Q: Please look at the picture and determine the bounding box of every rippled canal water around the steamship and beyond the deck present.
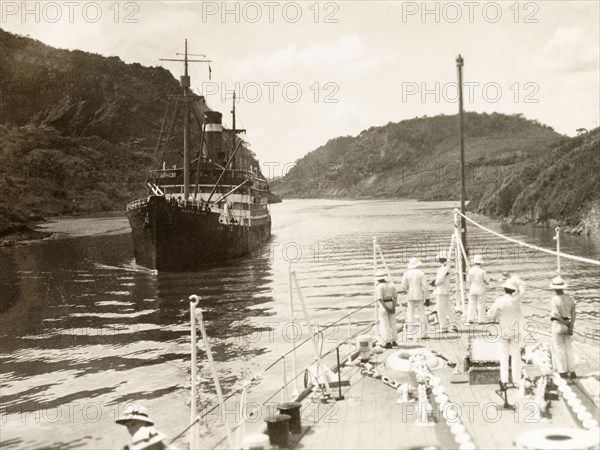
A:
[0,200,600,449]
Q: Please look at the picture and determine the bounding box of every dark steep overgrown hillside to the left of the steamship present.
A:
[0,29,258,238]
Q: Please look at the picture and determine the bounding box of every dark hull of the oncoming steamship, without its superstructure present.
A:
[127,196,271,271]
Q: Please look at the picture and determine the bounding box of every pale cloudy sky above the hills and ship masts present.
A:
[0,0,600,172]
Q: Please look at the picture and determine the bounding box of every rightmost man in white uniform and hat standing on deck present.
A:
[550,277,577,378]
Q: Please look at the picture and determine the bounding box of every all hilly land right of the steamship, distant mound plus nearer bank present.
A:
[274,113,600,232]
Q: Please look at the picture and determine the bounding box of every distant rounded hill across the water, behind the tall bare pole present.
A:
[274,113,565,200]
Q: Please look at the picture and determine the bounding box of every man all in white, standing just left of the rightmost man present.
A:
[488,279,523,384]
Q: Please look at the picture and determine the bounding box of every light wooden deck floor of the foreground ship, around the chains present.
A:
[294,327,599,449]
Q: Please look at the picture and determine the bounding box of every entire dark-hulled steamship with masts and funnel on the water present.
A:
[127,41,279,271]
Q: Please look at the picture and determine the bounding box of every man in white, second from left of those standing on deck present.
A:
[400,258,429,340]
